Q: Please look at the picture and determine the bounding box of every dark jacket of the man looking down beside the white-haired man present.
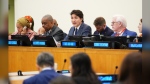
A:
[93,26,114,36]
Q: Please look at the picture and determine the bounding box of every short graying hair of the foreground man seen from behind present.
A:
[37,52,54,67]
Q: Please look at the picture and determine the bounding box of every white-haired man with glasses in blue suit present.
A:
[111,15,137,36]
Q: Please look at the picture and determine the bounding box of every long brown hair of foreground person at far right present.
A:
[119,52,142,84]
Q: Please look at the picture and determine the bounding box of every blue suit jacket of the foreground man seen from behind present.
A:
[23,69,59,84]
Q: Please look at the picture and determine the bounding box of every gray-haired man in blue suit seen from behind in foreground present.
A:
[23,52,59,84]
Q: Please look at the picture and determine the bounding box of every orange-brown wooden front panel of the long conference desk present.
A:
[8,46,138,74]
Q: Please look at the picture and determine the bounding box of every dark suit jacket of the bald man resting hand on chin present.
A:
[44,26,64,41]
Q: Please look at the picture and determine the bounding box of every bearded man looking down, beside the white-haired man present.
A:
[93,17,114,36]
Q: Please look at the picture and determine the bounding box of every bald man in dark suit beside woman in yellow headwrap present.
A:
[42,15,64,41]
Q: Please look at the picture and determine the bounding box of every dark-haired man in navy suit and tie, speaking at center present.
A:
[64,10,92,40]
